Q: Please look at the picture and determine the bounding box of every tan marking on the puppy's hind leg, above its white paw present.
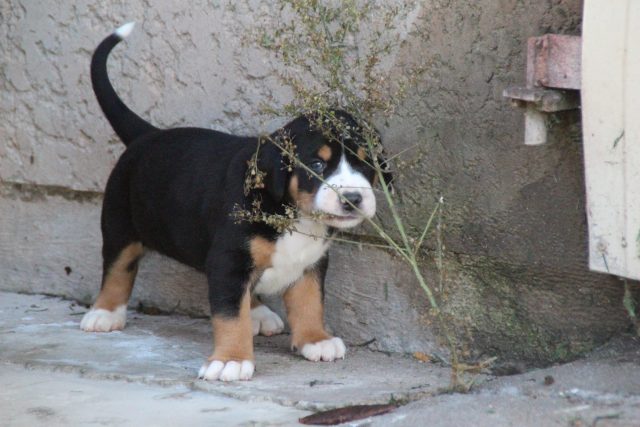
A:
[93,242,143,311]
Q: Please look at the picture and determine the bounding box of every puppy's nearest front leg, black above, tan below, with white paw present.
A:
[198,251,255,381]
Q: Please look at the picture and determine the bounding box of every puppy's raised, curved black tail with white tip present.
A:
[91,22,158,145]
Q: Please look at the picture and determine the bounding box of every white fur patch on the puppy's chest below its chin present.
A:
[255,219,330,294]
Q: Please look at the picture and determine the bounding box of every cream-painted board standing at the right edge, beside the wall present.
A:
[582,0,640,279]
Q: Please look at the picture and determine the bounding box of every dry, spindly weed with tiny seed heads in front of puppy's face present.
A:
[236,0,493,392]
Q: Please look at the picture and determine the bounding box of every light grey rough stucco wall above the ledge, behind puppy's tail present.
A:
[0,1,290,191]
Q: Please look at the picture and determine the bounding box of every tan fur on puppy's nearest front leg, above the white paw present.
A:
[209,290,253,362]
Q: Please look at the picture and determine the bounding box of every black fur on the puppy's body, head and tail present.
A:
[91,26,374,316]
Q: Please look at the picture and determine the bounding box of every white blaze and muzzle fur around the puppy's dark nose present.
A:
[314,154,376,228]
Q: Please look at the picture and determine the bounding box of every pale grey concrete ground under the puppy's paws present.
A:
[0,292,640,427]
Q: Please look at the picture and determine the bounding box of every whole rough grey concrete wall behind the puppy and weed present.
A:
[0,0,629,366]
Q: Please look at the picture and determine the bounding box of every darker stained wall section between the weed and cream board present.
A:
[385,1,628,364]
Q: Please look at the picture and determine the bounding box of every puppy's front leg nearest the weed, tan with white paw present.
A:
[284,270,346,362]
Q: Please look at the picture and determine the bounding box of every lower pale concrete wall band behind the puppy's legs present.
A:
[0,185,446,354]
